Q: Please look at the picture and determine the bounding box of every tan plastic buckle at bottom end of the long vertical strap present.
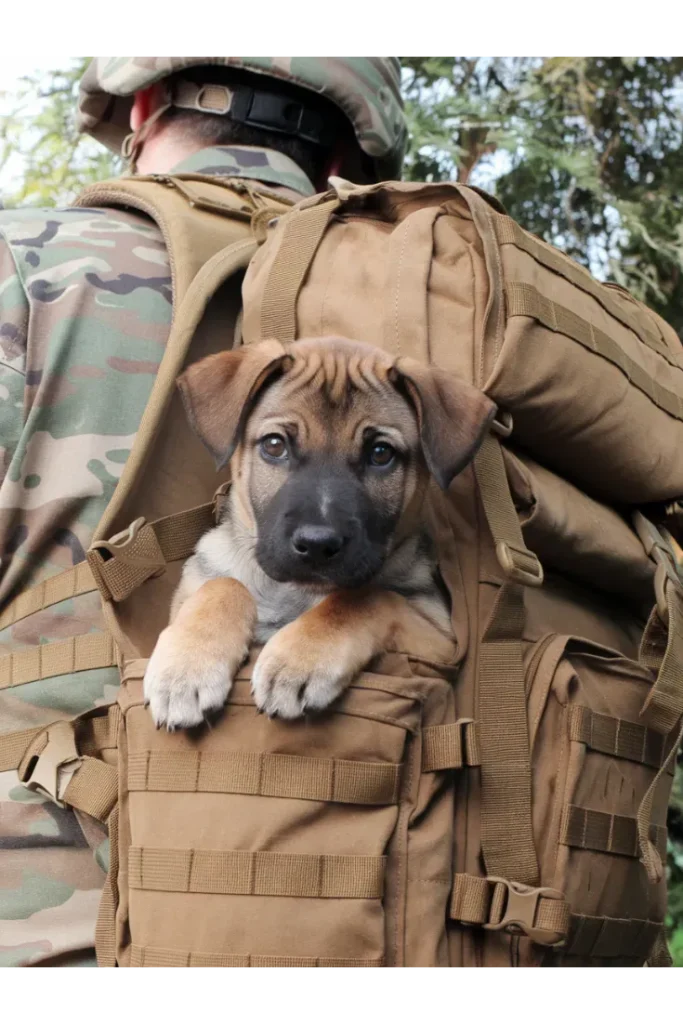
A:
[483,877,569,946]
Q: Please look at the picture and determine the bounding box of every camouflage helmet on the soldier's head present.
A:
[78,56,408,179]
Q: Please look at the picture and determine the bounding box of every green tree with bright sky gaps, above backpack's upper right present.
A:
[402,56,683,335]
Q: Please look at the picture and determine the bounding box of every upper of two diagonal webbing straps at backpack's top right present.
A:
[494,217,683,370]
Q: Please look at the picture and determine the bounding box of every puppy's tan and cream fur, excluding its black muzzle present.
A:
[145,339,493,728]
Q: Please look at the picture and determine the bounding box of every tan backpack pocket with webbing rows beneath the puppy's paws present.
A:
[108,659,454,967]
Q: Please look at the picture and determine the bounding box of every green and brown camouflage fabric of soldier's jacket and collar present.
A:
[0,146,313,968]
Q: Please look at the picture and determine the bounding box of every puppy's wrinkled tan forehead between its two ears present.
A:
[244,342,417,444]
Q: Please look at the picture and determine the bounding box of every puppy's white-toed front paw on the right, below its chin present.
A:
[252,622,361,719]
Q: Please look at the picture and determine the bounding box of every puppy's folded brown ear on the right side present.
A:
[393,358,496,490]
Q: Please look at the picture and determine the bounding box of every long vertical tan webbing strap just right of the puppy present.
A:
[474,434,543,885]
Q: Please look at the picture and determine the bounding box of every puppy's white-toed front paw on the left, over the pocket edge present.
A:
[144,626,248,732]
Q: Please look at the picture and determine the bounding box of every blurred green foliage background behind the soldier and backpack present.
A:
[0,56,683,967]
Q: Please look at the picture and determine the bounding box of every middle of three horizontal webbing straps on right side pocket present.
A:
[559,804,667,857]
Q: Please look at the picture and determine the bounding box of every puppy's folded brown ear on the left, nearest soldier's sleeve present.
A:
[178,341,290,469]
